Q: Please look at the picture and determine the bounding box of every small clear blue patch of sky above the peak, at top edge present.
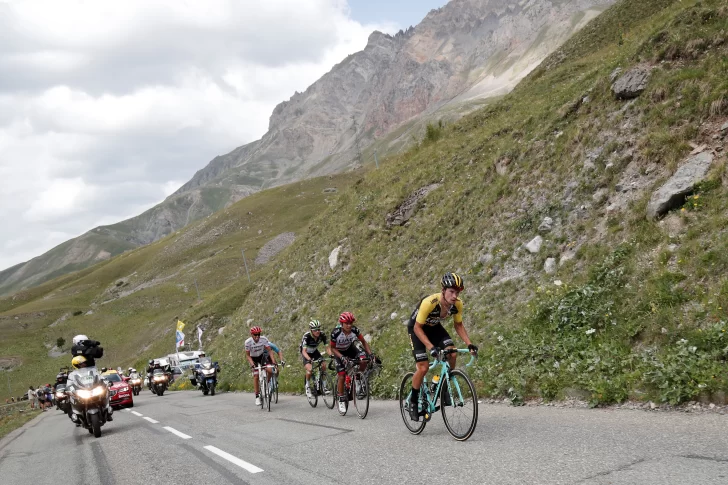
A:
[348,0,447,28]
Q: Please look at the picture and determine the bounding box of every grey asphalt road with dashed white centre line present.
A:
[0,390,728,485]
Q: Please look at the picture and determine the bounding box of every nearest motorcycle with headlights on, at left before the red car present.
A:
[70,371,109,438]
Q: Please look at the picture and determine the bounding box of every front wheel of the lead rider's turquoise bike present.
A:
[440,369,478,441]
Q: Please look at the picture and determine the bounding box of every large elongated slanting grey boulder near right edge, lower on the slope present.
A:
[647,152,713,219]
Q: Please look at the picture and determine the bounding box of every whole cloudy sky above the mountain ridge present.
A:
[0,0,446,269]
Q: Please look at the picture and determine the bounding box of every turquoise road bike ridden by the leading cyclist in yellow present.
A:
[399,349,478,441]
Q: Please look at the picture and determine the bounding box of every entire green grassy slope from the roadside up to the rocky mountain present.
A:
[0,0,728,404]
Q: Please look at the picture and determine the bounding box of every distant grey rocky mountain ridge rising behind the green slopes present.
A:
[0,0,614,294]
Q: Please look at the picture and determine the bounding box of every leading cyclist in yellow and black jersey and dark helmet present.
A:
[407,273,478,421]
